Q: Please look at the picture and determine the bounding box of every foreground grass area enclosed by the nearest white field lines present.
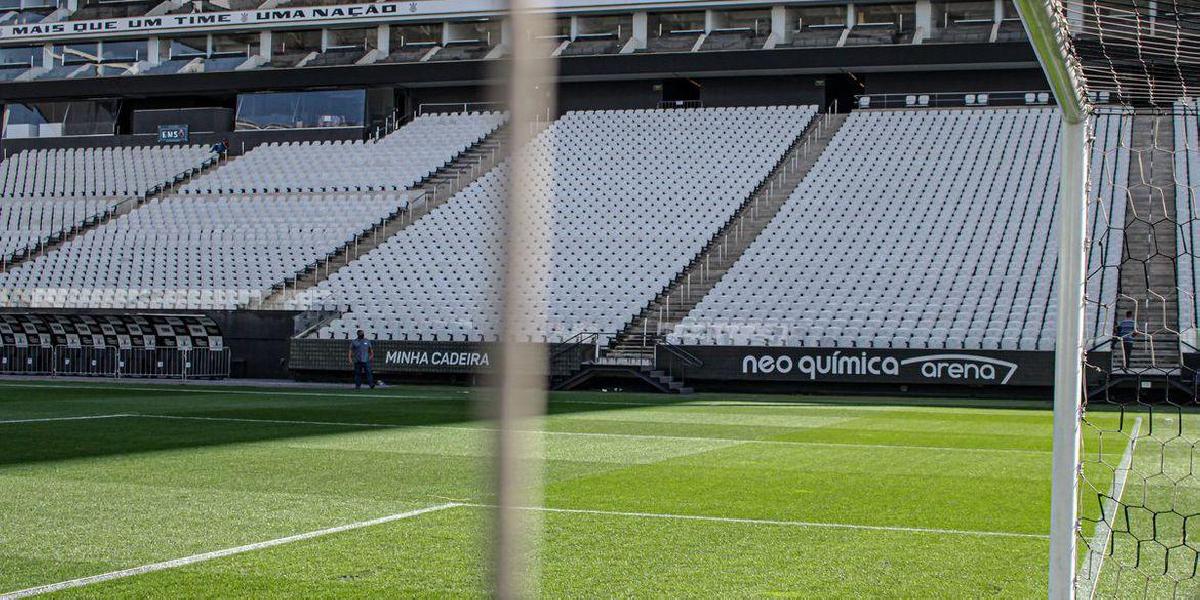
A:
[51,510,1046,599]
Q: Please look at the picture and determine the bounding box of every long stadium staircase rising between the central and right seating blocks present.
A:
[605,113,847,361]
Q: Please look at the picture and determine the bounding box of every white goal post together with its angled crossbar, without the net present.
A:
[1015,0,1091,600]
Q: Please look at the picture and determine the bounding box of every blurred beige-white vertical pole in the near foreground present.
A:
[492,0,554,599]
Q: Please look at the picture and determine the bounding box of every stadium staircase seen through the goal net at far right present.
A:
[1112,115,1181,376]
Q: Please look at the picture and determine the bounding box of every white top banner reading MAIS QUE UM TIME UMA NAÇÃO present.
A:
[0,0,714,42]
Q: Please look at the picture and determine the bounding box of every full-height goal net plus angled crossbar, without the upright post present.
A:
[1022,0,1200,590]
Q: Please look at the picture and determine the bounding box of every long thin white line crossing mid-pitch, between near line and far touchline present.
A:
[128,414,1050,455]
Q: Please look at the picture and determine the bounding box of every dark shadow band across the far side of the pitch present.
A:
[0,380,1099,464]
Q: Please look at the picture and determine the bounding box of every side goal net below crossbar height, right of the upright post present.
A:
[1078,102,1200,598]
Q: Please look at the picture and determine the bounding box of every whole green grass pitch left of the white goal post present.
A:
[0,382,1171,598]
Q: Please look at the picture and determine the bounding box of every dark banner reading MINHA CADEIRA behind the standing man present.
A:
[288,340,498,374]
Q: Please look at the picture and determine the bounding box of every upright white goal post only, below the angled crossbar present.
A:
[1049,113,1090,600]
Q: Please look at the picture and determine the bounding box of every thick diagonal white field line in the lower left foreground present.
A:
[0,502,463,600]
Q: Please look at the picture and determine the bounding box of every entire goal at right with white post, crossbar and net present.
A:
[1015,0,1200,599]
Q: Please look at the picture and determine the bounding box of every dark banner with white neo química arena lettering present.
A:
[658,346,1054,386]
